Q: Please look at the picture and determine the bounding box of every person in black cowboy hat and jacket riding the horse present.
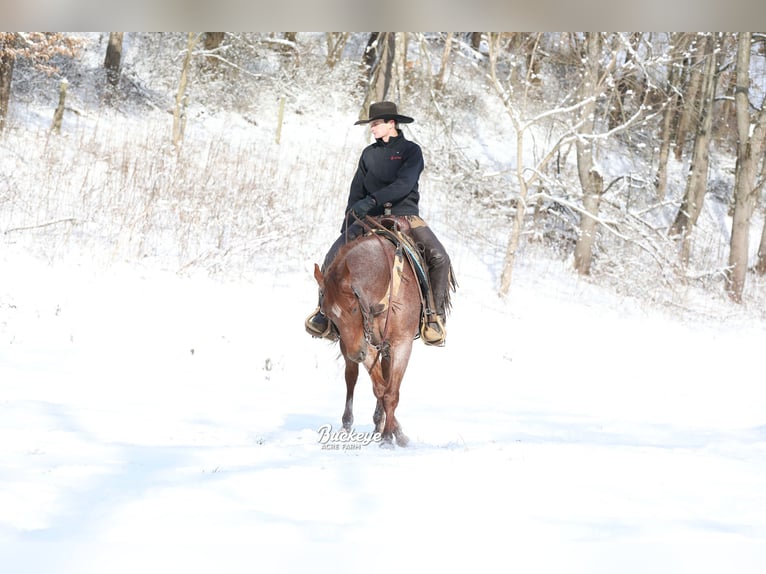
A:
[305,102,450,345]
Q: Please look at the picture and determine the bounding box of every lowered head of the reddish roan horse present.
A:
[314,264,368,363]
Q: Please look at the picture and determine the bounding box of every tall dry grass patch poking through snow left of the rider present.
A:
[0,112,348,280]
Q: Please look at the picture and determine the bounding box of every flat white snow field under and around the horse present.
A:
[0,240,766,574]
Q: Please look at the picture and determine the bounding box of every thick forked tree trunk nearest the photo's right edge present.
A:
[726,32,766,303]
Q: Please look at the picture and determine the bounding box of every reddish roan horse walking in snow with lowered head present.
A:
[314,220,423,448]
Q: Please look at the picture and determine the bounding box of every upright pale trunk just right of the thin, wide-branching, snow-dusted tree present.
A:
[574,32,604,275]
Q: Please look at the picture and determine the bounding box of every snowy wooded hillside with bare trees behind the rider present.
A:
[0,32,766,310]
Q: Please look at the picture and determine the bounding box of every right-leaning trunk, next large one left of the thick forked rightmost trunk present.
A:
[669,34,716,260]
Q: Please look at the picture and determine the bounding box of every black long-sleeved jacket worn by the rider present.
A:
[346,132,423,222]
